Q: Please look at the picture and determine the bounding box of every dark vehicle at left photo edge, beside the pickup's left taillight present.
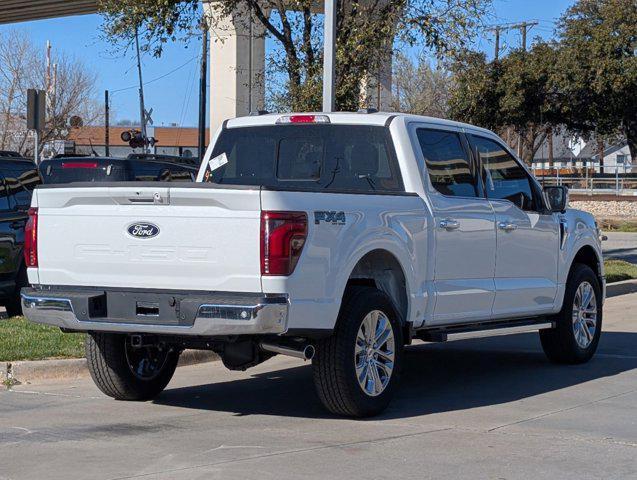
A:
[0,155,40,316]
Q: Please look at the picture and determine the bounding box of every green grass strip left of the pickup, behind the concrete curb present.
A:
[0,317,84,362]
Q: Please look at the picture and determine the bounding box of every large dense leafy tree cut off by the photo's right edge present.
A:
[552,0,637,161]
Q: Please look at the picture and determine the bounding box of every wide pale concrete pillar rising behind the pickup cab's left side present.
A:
[204,3,265,133]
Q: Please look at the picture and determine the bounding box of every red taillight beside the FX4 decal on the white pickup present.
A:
[261,212,307,276]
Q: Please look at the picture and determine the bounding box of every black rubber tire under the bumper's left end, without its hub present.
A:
[85,332,179,401]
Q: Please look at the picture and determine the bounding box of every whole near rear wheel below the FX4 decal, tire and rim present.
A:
[312,287,403,417]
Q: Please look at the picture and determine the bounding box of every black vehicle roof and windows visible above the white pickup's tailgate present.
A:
[40,156,198,184]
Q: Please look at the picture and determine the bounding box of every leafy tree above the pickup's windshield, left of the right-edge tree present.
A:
[450,42,558,164]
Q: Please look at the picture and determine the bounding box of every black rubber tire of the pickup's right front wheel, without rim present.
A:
[540,263,602,365]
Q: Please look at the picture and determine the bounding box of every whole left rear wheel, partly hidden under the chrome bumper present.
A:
[86,332,179,401]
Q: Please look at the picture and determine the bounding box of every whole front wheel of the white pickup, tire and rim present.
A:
[540,264,602,364]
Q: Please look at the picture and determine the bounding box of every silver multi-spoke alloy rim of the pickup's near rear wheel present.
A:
[354,310,396,397]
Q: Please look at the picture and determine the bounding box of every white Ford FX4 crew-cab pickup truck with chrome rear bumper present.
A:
[22,112,605,417]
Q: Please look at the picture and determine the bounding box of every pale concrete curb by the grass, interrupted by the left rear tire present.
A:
[0,350,219,385]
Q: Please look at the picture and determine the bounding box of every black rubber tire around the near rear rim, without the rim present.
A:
[312,287,403,417]
